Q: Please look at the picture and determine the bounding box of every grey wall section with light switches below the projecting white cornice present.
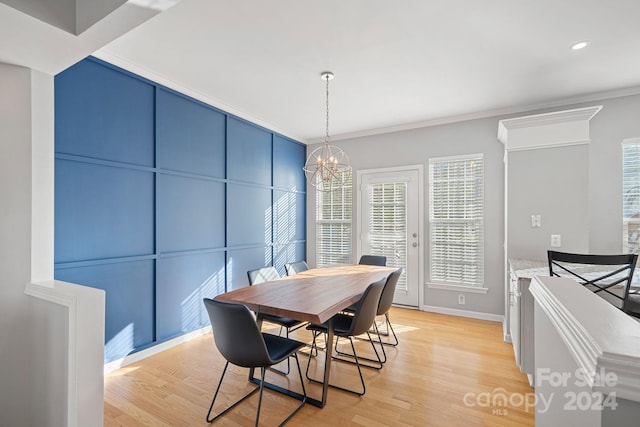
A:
[507,144,589,261]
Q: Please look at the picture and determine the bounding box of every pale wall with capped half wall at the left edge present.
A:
[0,63,104,427]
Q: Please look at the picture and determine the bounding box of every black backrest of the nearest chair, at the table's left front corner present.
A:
[203,298,271,368]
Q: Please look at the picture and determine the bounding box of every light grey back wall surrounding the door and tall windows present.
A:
[307,118,504,315]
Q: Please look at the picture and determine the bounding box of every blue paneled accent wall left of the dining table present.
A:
[55,57,306,362]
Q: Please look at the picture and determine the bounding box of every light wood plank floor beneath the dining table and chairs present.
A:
[104,307,534,427]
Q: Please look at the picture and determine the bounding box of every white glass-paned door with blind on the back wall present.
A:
[357,165,424,307]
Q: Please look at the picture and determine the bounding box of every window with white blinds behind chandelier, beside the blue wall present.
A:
[316,173,353,267]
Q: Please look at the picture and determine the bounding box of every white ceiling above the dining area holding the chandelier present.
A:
[0,0,640,142]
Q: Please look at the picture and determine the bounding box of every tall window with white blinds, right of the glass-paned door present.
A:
[429,154,484,287]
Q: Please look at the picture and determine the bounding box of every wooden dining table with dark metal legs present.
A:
[215,264,397,408]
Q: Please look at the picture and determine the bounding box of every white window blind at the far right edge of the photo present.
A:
[622,138,640,254]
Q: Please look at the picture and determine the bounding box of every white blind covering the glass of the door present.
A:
[369,181,407,290]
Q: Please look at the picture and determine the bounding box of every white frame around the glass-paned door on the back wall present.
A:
[355,164,424,310]
